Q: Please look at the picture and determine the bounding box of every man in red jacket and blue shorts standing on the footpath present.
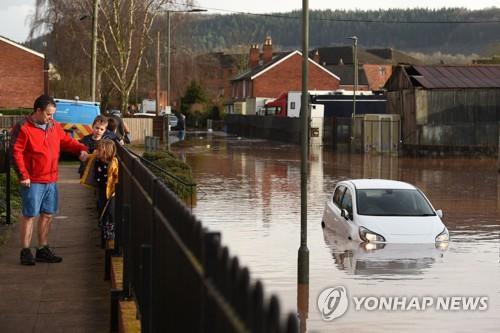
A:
[12,95,88,265]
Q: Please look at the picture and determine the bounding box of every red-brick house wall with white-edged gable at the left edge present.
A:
[0,36,46,108]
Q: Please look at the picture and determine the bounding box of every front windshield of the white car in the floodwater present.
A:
[356,189,436,216]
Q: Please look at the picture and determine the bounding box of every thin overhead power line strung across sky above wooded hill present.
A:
[171,1,500,24]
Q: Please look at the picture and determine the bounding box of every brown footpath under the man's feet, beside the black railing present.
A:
[0,165,110,333]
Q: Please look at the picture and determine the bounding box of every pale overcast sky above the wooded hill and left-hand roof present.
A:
[0,0,500,42]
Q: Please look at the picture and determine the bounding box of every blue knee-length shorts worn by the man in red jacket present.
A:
[20,183,58,217]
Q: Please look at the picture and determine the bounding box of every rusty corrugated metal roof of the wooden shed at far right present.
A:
[411,65,500,89]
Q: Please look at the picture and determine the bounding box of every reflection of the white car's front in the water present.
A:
[323,228,448,280]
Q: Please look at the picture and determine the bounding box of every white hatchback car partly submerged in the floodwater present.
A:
[322,179,449,244]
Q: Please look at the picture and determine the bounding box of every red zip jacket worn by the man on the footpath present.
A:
[11,116,87,183]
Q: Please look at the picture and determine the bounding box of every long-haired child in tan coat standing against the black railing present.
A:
[80,139,118,245]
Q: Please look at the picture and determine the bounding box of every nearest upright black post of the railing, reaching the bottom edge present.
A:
[140,244,154,333]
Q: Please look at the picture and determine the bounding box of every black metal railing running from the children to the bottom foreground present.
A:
[115,147,298,333]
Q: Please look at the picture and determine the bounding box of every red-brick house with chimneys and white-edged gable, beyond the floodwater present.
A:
[231,47,340,102]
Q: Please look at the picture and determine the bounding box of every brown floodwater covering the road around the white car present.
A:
[173,135,500,332]
